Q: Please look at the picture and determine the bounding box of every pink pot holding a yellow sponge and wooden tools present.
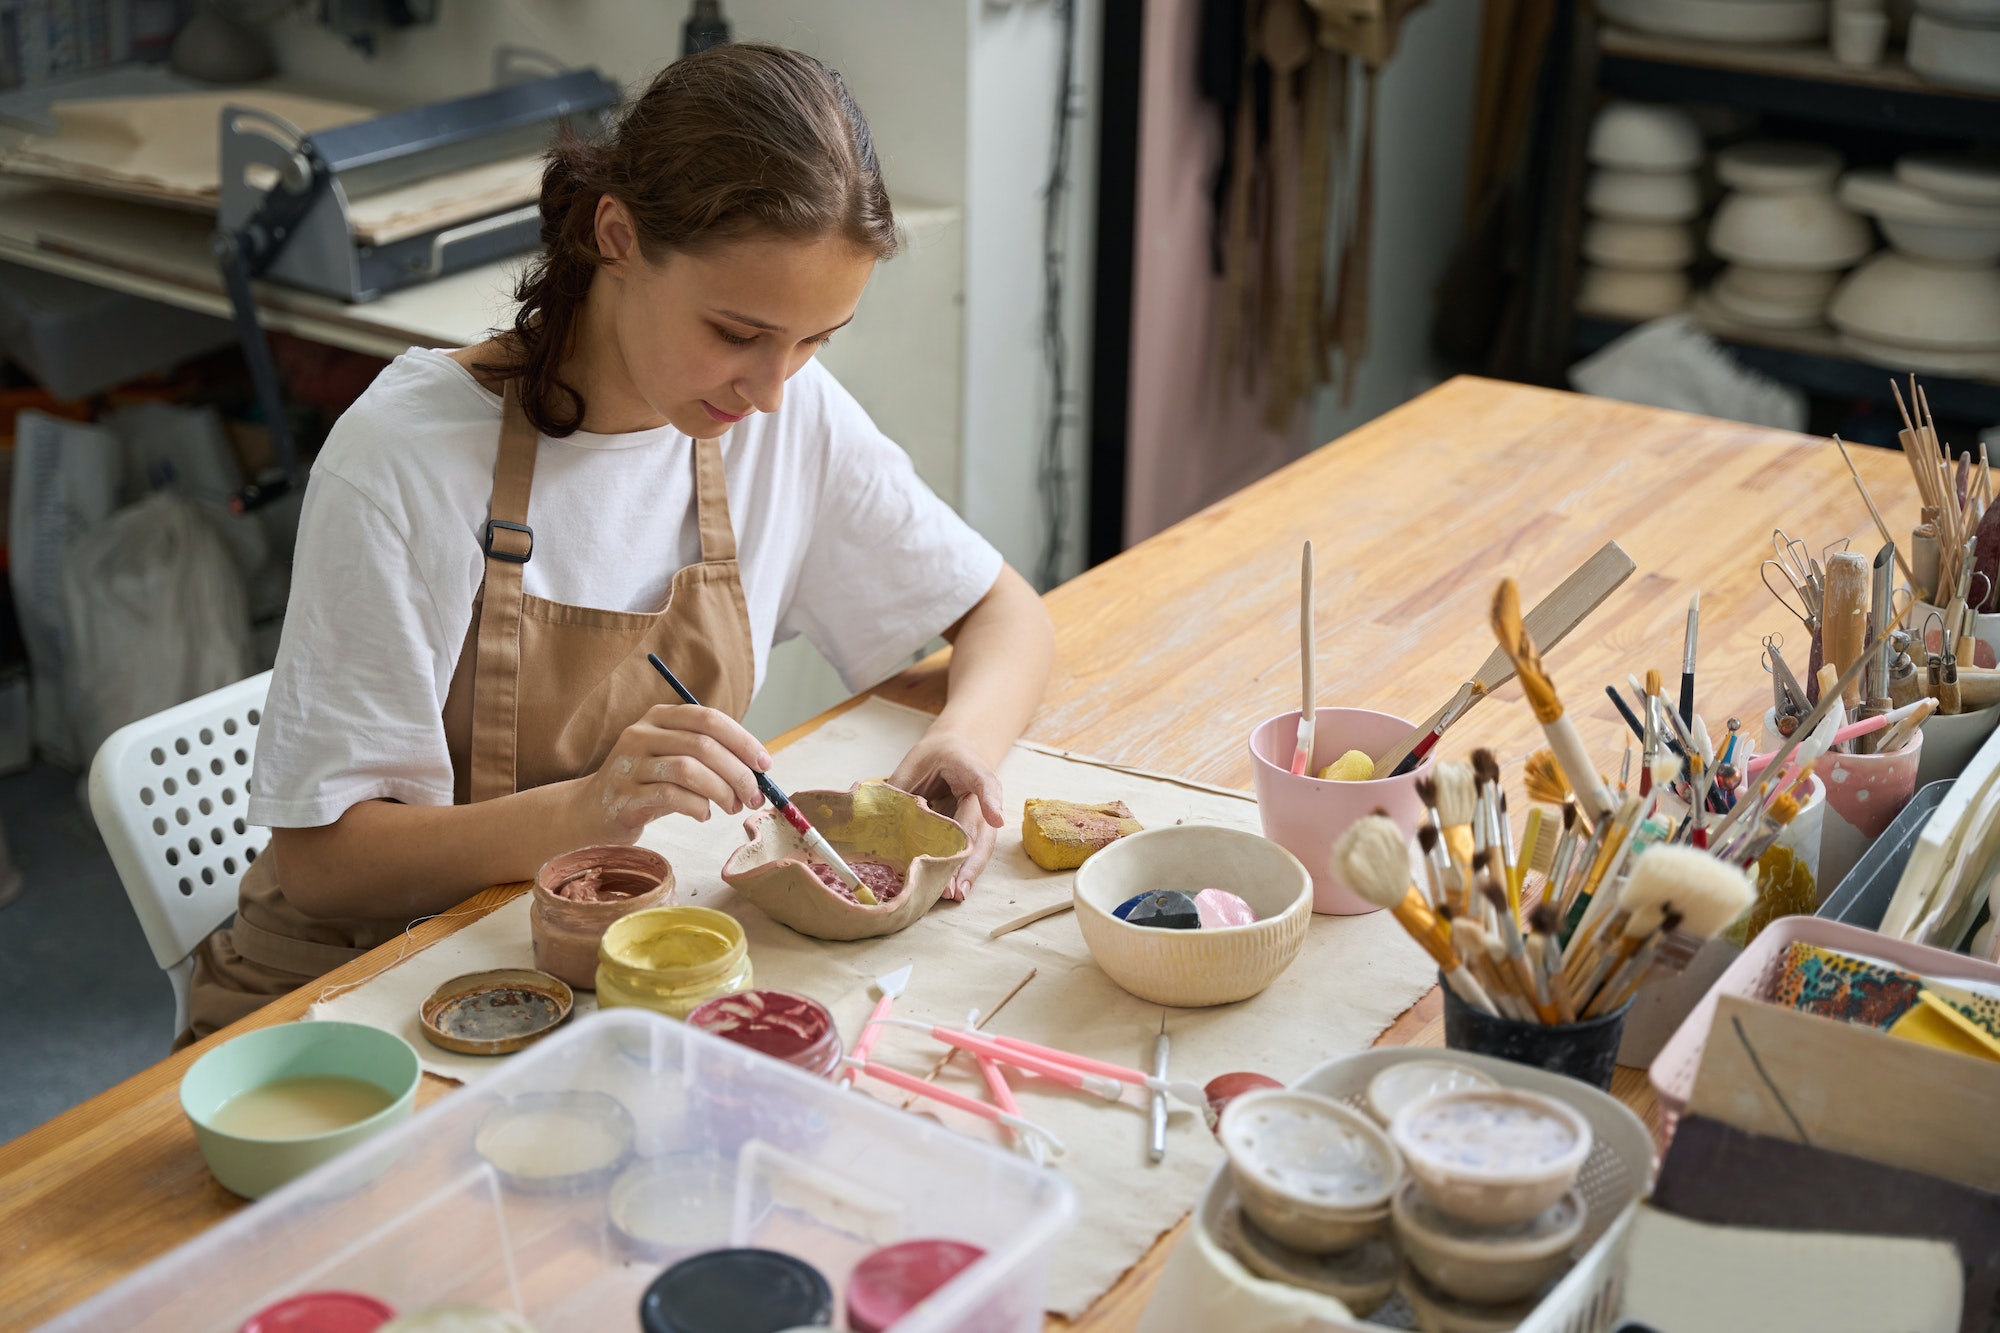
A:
[1250,709,1430,917]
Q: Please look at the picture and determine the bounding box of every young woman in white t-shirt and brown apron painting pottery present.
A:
[186,46,1052,1039]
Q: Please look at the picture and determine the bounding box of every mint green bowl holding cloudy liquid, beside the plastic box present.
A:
[180,1023,424,1199]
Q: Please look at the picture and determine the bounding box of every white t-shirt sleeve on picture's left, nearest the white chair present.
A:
[248,470,456,829]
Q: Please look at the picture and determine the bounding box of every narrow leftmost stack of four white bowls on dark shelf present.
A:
[1576,102,1702,320]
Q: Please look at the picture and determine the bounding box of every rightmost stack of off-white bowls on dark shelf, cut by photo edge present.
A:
[1828,154,2000,374]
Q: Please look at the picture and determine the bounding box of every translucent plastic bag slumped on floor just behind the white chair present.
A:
[62,492,252,755]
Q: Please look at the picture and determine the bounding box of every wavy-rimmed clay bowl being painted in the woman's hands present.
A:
[722,783,972,939]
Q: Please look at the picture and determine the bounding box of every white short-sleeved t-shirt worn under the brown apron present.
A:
[248,348,1000,829]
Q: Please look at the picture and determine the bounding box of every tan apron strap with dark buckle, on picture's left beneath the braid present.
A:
[468,380,540,801]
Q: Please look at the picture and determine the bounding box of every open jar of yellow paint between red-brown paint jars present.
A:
[598,907,750,1019]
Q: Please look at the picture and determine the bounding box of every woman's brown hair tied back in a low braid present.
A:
[480,42,896,438]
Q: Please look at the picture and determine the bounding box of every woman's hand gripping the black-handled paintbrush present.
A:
[578,705,770,843]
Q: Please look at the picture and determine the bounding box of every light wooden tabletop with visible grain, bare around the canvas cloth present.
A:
[0,378,1916,1331]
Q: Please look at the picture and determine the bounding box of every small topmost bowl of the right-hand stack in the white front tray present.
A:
[1388,1089,1592,1227]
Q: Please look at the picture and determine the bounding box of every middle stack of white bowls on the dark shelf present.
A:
[1708,140,1874,328]
